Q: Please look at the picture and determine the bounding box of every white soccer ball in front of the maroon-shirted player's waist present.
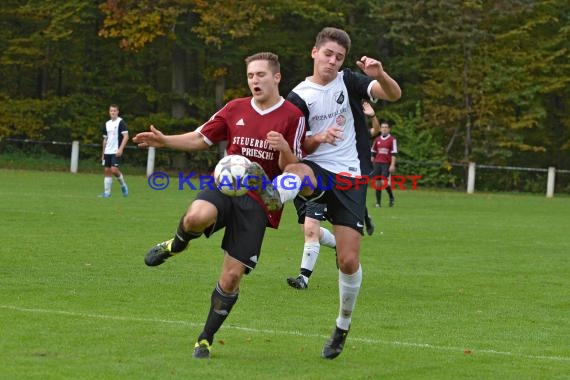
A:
[214,154,251,197]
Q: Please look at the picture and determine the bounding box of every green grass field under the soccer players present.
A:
[0,170,570,380]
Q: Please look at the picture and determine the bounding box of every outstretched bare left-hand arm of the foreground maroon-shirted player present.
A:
[133,125,209,152]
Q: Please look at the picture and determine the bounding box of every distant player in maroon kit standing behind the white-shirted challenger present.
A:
[372,121,398,207]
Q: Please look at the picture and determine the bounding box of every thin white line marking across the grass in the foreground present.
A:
[0,305,570,362]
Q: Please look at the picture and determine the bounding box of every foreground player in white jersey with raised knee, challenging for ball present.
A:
[260,27,401,359]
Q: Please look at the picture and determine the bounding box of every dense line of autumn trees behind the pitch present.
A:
[0,0,570,187]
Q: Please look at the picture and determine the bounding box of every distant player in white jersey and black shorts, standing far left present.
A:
[99,104,129,198]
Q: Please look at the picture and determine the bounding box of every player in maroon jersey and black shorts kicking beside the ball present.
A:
[133,53,305,358]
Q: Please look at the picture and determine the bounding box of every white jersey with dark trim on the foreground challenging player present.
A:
[292,71,374,176]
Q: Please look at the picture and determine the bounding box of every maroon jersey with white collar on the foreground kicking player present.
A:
[200,97,305,228]
